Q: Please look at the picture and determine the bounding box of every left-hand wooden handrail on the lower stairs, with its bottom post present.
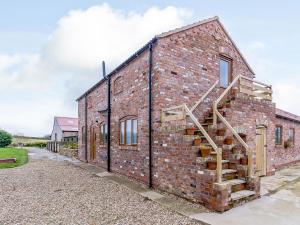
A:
[183,104,222,183]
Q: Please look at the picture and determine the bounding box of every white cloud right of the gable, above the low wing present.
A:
[245,41,300,115]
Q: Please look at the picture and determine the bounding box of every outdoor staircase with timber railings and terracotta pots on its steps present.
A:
[162,75,272,210]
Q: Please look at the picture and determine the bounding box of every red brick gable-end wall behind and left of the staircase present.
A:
[153,21,253,202]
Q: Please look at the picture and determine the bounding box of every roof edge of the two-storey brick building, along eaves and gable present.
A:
[76,16,255,101]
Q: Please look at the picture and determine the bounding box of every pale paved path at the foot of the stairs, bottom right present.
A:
[192,164,300,225]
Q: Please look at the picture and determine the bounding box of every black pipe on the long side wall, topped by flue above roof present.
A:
[102,61,111,172]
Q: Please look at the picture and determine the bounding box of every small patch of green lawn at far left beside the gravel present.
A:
[0,148,28,169]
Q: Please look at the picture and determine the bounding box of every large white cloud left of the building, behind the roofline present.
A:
[0,4,191,135]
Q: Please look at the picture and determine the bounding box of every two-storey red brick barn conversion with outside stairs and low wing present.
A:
[77,17,300,211]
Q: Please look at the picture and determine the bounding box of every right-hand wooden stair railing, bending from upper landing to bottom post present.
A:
[213,75,253,177]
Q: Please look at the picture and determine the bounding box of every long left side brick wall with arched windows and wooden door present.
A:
[78,51,149,183]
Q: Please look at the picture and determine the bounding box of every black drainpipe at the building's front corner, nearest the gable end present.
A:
[148,43,153,188]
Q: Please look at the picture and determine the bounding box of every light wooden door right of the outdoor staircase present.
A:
[256,127,267,176]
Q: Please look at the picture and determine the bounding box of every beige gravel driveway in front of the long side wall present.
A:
[0,149,201,225]
